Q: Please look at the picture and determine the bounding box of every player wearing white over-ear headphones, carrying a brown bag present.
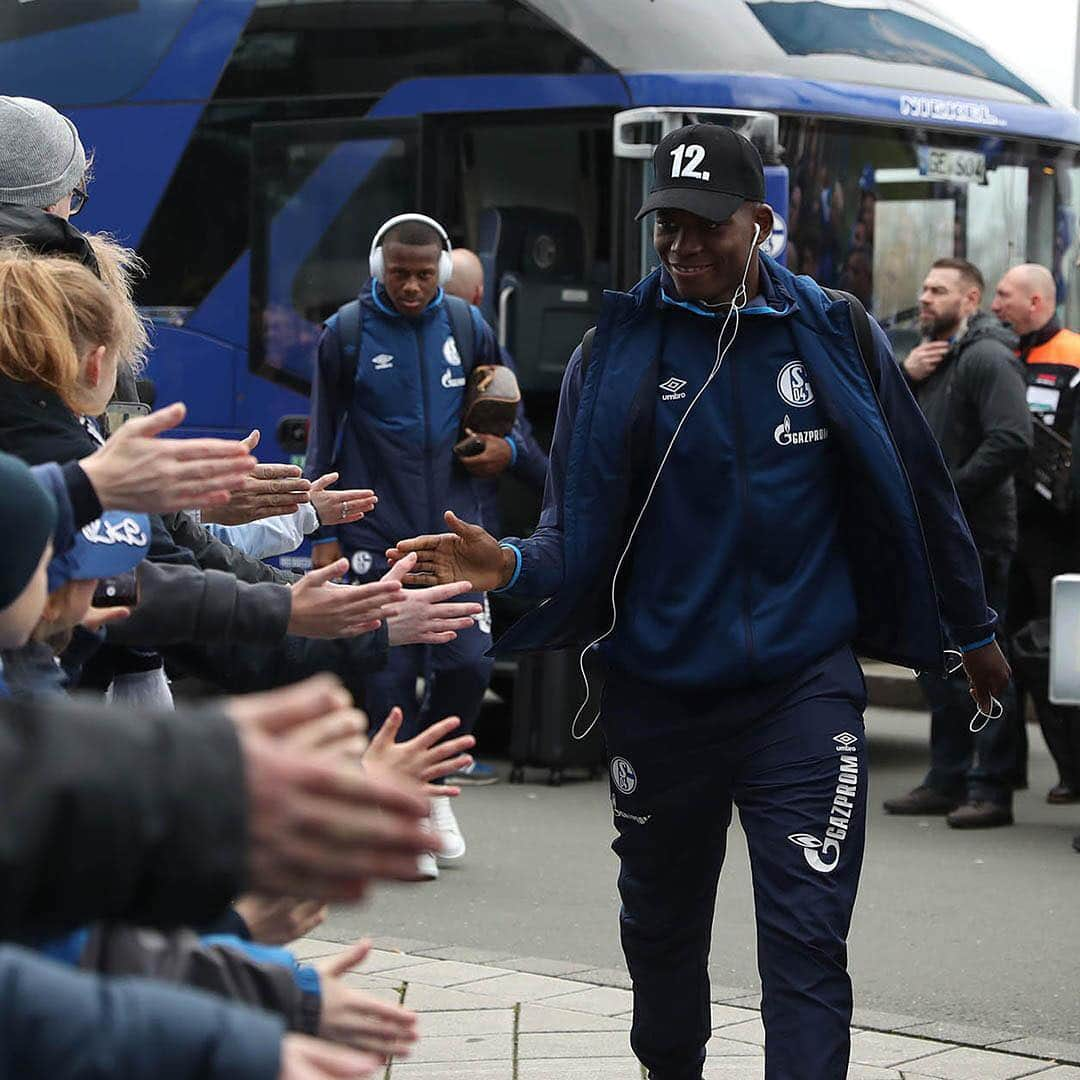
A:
[307,213,531,878]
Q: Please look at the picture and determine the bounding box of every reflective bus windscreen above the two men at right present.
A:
[781,118,1080,353]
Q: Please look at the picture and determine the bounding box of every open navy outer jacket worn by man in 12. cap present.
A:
[496,256,996,688]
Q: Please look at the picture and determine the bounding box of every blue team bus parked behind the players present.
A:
[0,0,1080,552]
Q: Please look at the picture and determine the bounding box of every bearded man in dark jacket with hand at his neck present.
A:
[885,258,1031,828]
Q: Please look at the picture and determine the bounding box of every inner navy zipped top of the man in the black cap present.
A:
[602,275,856,689]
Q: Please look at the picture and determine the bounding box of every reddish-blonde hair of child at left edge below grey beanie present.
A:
[0,245,122,407]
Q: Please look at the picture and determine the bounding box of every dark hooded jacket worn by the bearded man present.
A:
[912,311,1032,553]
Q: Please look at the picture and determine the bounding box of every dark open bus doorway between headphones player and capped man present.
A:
[436,111,611,392]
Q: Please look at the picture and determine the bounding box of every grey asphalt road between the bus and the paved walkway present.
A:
[326,708,1080,1042]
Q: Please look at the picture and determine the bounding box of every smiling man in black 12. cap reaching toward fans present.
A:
[392,124,1009,1080]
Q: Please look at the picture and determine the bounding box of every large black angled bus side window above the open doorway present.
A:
[137,0,604,317]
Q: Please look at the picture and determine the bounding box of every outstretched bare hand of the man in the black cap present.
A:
[387,510,515,593]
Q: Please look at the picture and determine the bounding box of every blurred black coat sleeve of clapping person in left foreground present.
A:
[0,697,247,937]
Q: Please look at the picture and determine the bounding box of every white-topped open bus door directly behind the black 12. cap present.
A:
[612,108,788,288]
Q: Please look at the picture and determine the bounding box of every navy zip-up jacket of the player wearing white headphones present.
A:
[306,282,546,552]
